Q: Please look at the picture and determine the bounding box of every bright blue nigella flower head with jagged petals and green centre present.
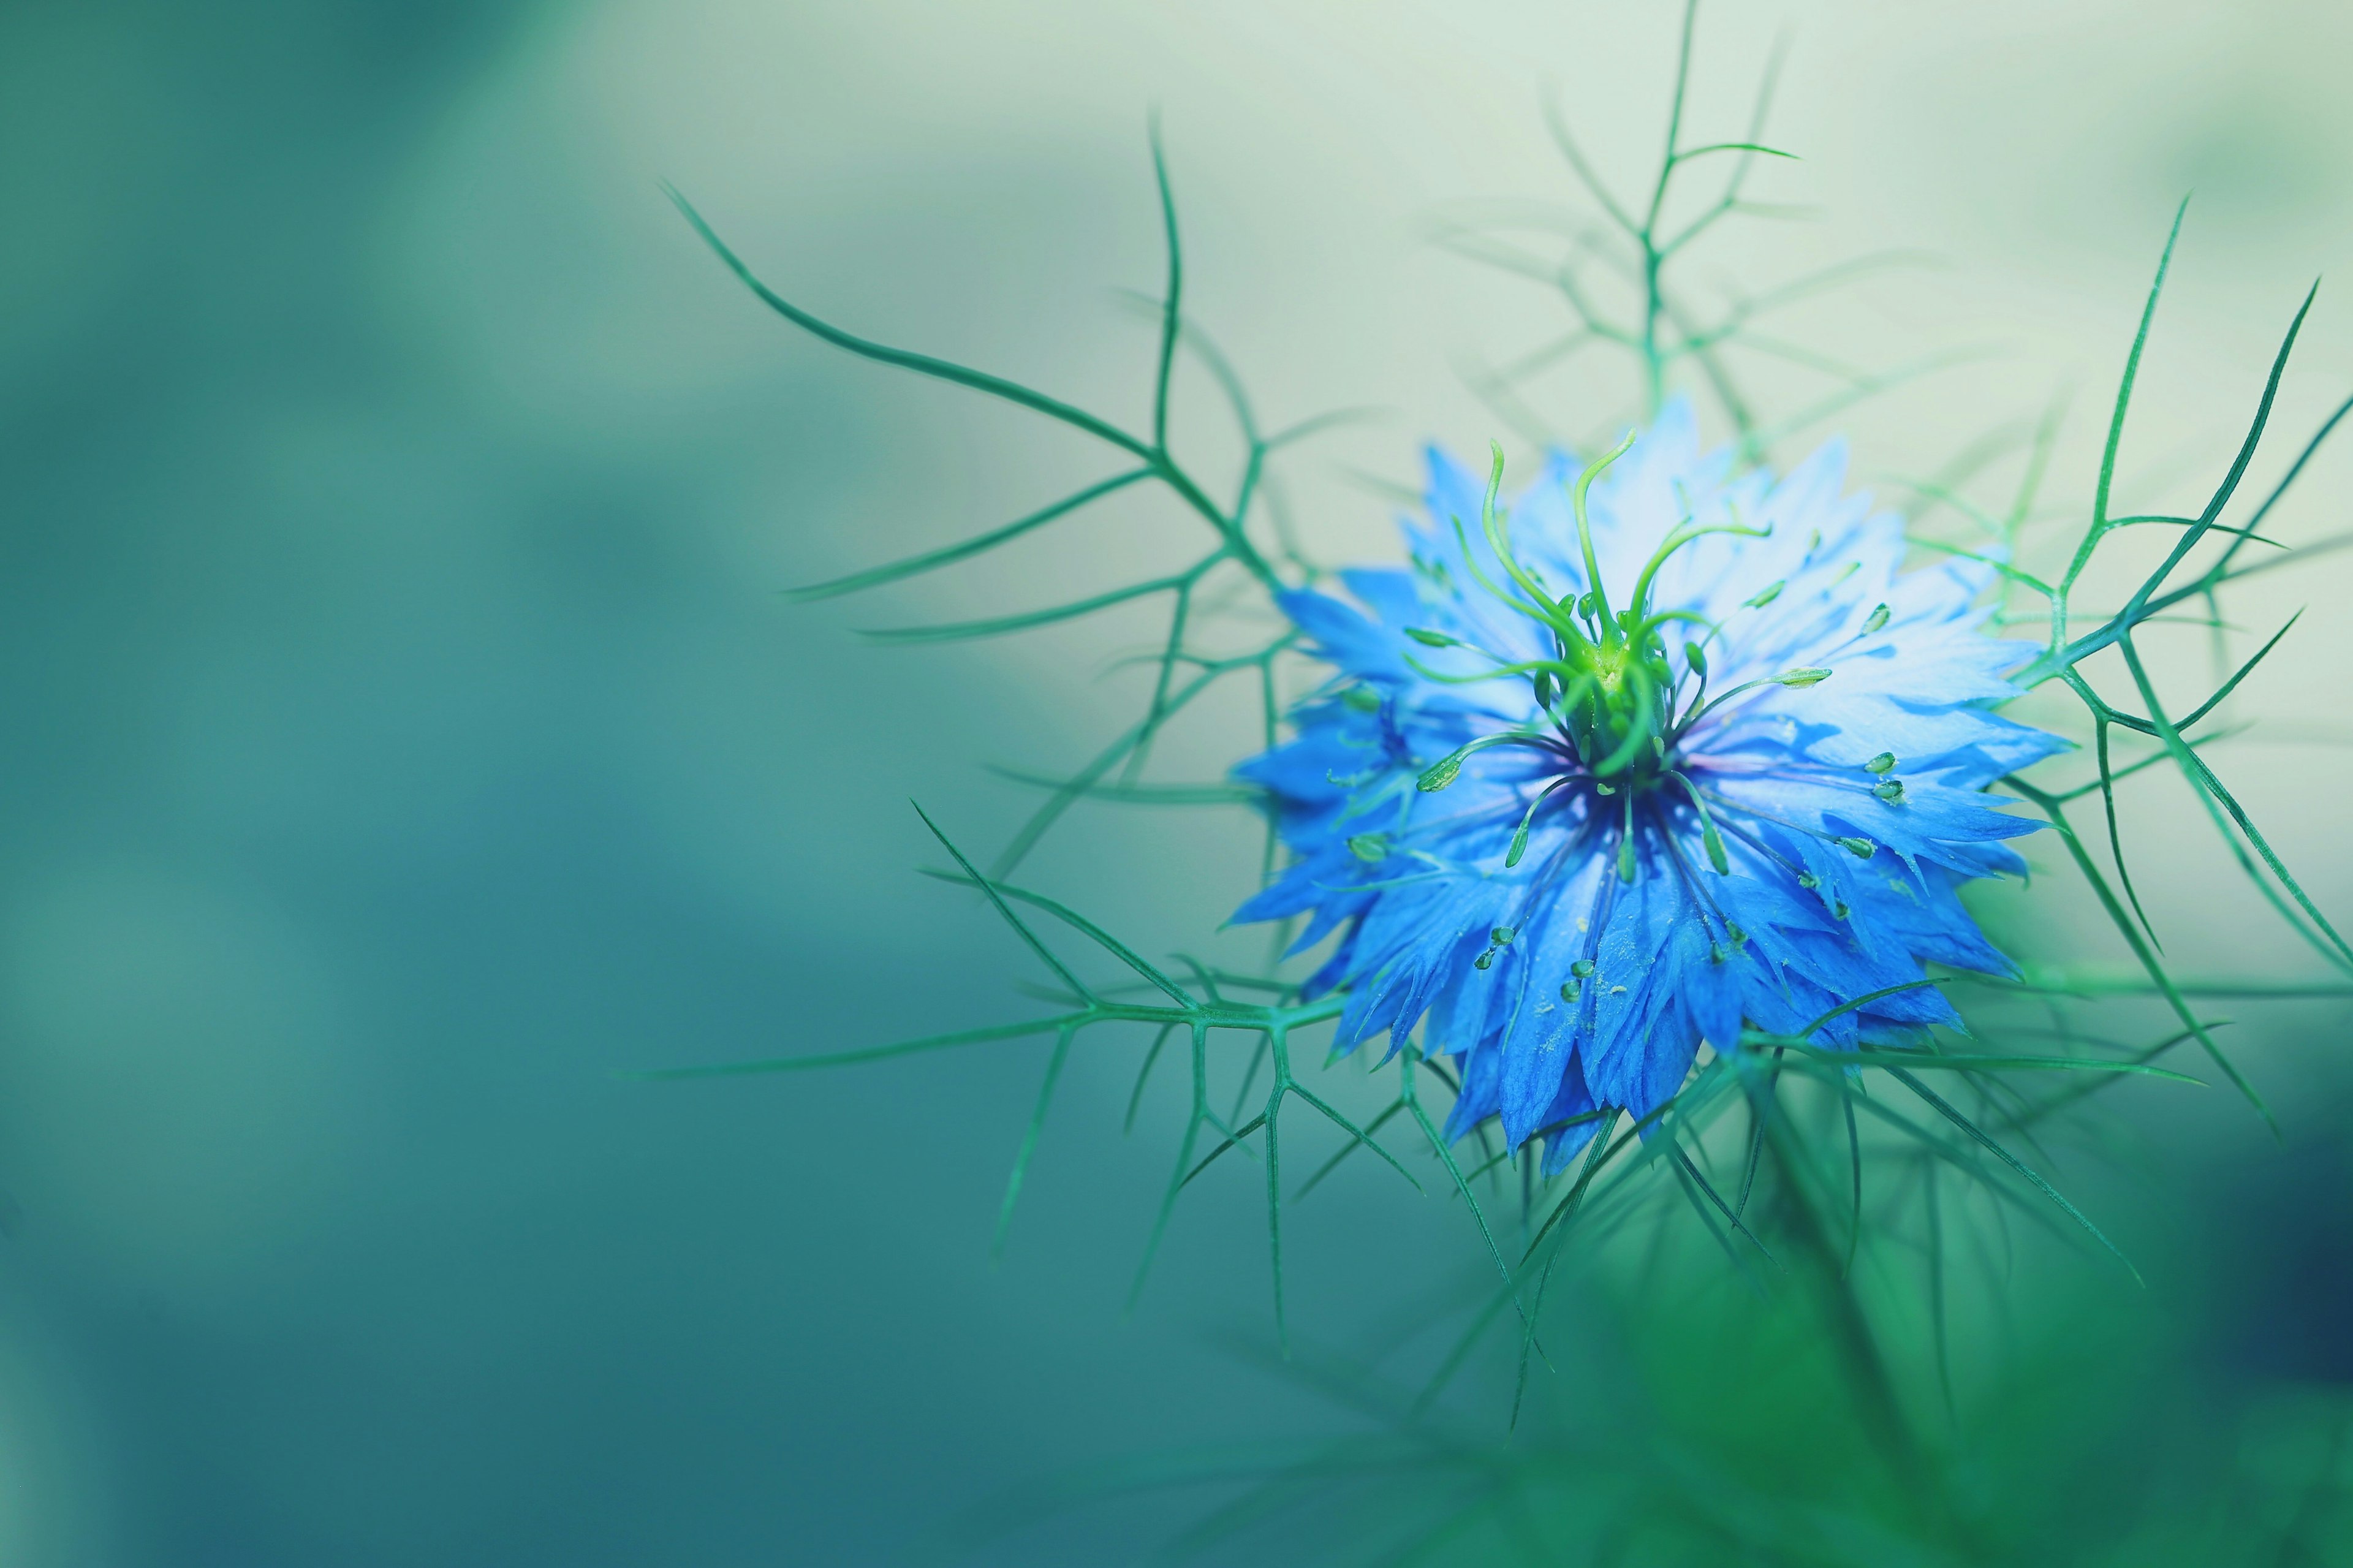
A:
[1235,405,2064,1170]
